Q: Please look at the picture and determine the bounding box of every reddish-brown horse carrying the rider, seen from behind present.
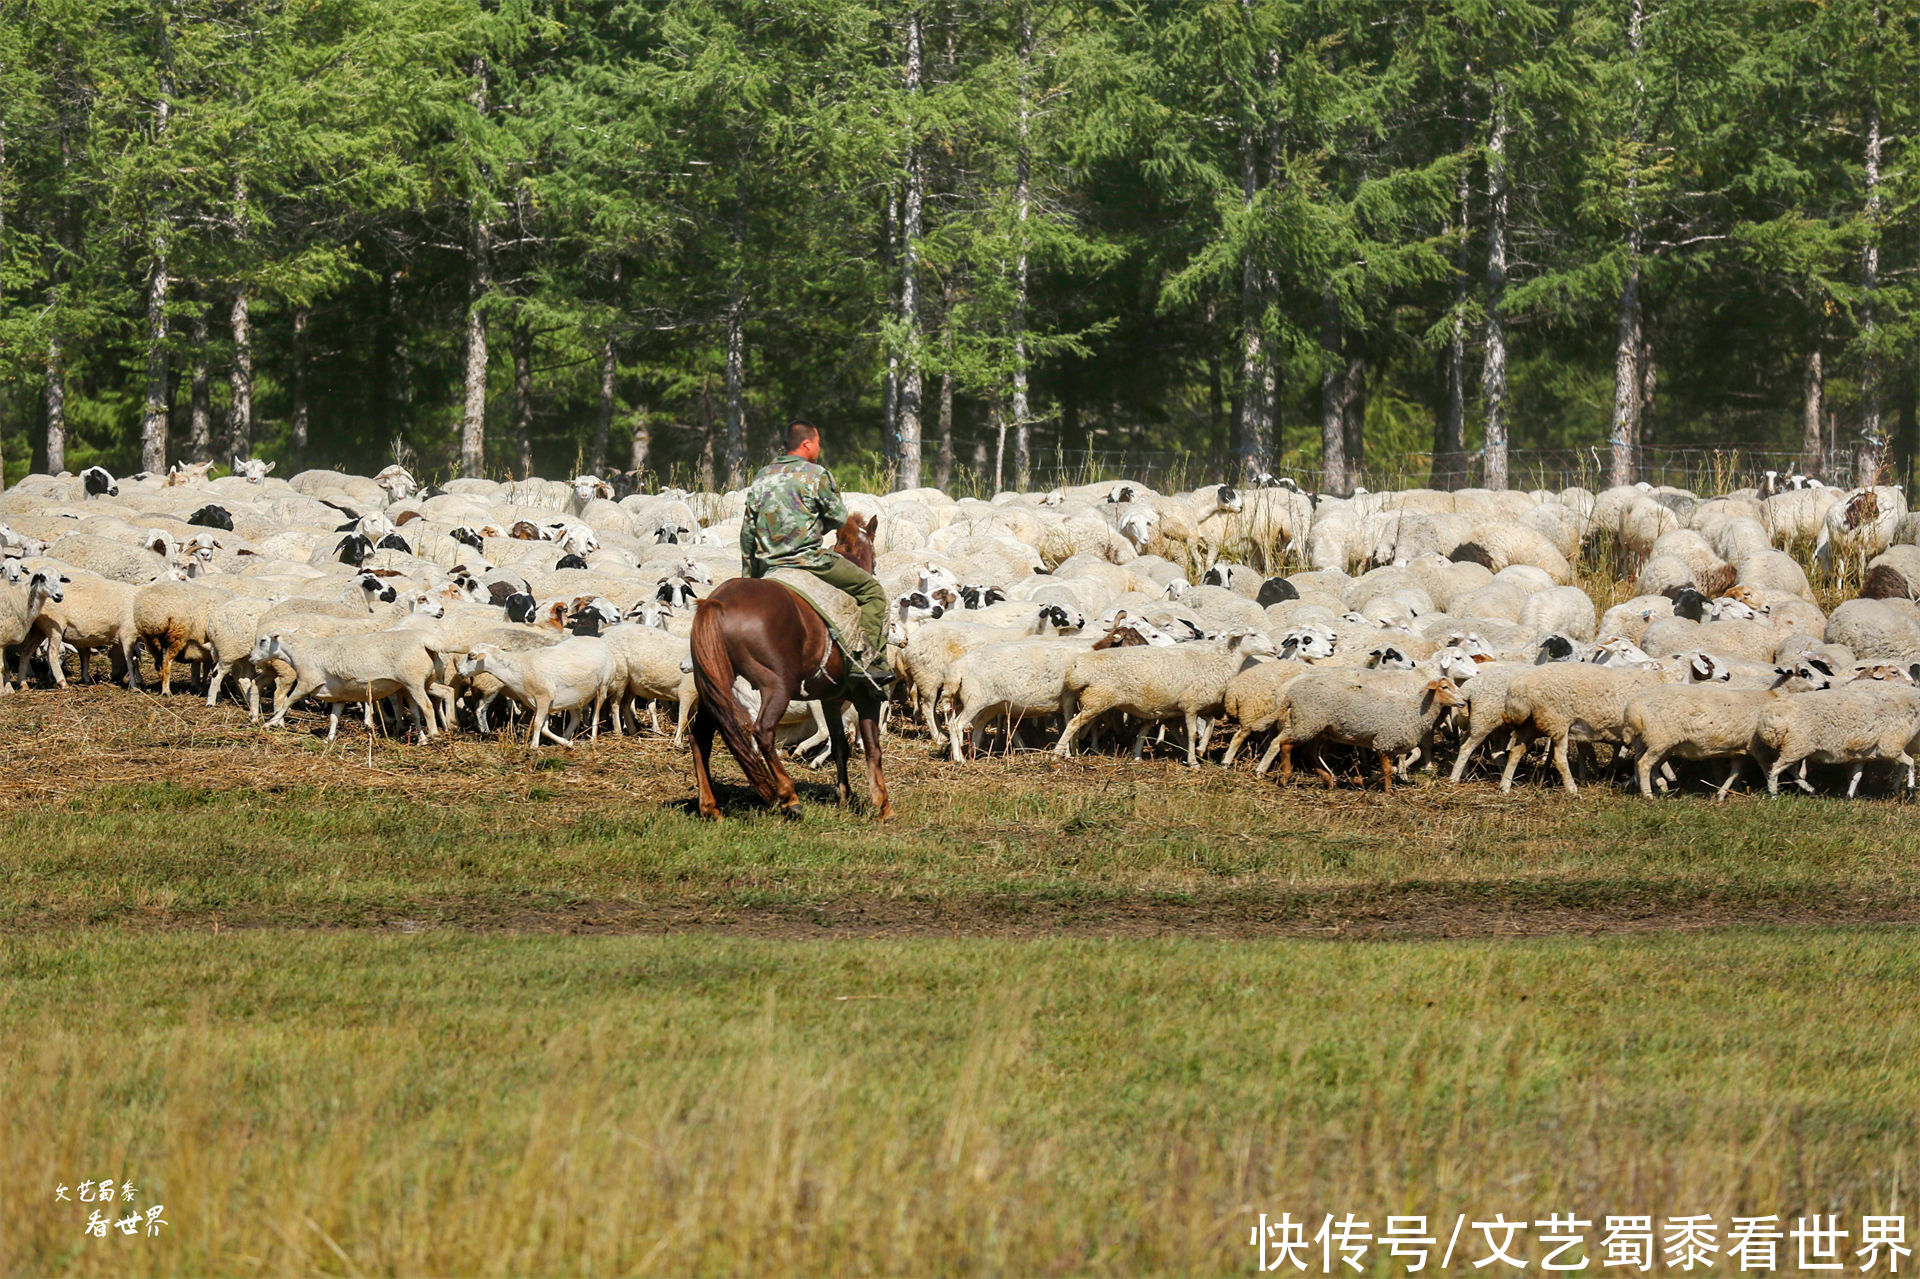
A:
[691,517,893,820]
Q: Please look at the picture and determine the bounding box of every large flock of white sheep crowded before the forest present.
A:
[0,459,1920,795]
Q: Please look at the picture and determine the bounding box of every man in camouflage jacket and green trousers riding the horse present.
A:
[739,422,893,688]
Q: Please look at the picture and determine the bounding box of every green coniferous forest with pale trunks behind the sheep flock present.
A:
[0,0,1920,492]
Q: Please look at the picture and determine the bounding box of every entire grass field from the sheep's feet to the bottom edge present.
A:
[0,691,1920,1275]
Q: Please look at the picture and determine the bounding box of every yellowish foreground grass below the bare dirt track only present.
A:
[0,929,1920,1275]
